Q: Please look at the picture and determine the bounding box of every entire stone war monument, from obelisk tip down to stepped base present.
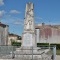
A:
[15,2,49,60]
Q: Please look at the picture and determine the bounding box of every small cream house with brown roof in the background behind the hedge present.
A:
[8,33,22,45]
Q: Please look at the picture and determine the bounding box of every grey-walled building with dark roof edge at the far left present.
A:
[0,22,9,45]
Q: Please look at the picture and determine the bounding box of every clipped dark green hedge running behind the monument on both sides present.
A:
[11,42,60,49]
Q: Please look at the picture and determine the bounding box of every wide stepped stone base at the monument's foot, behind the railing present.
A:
[15,46,51,60]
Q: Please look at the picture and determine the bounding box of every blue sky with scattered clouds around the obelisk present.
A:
[0,0,60,35]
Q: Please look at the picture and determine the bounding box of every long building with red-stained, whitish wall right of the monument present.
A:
[35,23,60,43]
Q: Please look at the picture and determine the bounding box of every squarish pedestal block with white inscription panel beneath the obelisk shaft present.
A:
[22,32,37,48]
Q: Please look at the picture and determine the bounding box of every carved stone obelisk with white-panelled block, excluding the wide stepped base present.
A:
[22,2,36,47]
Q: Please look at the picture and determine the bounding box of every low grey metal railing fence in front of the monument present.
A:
[0,46,56,60]
